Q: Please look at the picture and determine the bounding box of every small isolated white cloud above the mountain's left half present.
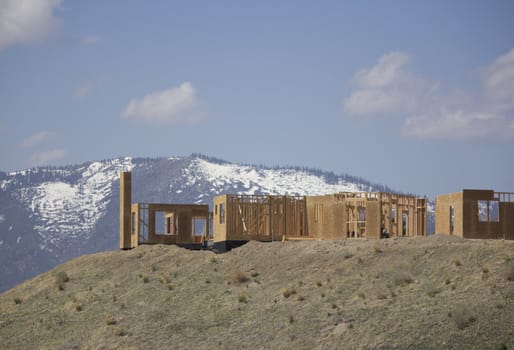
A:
[121,82,205,124]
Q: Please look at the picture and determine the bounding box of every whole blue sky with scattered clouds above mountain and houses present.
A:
[0,0,514,197]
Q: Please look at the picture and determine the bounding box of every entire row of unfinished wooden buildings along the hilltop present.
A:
[120,172,514,252]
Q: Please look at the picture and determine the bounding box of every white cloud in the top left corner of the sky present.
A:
[0,0,62,50]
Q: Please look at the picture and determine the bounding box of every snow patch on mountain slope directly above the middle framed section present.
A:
[184,158,362,196]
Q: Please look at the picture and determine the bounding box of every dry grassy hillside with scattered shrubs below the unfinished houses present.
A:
[0,237,514,349]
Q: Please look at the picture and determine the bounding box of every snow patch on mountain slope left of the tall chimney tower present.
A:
[12,158,133,251]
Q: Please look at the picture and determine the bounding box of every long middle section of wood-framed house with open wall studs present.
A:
[213,192,426,249]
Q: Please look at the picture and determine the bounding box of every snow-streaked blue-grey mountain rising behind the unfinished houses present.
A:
[0,154,430,291]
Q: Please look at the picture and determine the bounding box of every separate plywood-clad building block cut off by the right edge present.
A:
[435,190,514,239]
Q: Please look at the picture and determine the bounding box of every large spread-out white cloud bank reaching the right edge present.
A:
[343,49,514,140]
